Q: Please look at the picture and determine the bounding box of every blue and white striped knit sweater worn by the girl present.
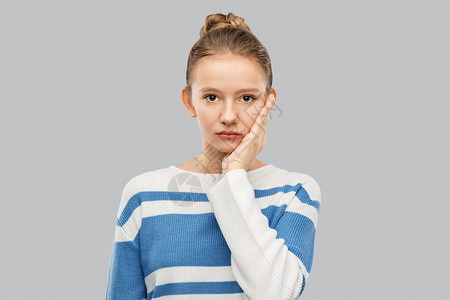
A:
[106,164,321,300]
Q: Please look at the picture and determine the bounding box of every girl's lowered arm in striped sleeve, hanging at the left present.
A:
[106,181,147,300]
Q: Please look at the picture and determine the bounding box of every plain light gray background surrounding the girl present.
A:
[0,0,450,300]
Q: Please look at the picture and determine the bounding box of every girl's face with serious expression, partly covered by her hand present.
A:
[183,54,276,153]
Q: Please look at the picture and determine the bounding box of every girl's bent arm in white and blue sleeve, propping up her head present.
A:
[207,169,320,299]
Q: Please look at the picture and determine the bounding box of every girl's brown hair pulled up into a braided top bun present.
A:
[186,12,272,95]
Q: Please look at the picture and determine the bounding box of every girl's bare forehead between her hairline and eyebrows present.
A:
[192,54,265,91]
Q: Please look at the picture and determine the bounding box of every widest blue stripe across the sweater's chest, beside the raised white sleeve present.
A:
[140,213,231,276]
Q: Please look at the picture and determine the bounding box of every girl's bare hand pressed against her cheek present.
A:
[222,95,275,174]
